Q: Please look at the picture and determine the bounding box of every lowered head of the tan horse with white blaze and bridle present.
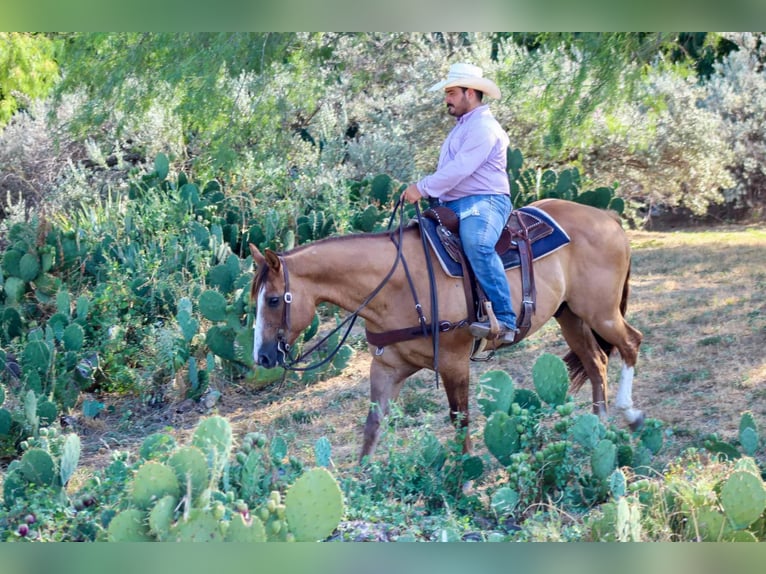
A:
[250,243,316,368]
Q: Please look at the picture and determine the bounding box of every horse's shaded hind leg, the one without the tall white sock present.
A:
[556,306,609,419]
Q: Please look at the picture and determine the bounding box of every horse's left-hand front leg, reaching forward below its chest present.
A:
[359,360,419,462]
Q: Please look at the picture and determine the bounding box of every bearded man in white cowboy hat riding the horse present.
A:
[402,64,517,343]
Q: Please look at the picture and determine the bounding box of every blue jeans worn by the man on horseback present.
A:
[444,195,516,329]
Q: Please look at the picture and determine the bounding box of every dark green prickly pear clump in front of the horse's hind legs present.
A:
[478,353,664,507]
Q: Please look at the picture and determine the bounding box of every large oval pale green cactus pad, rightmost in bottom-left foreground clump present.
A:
[285,468,343,542]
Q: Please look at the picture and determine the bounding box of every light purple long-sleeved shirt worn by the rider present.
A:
[417,105,510,201]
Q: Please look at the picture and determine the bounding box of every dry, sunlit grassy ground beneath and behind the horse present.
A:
[76,226,766,469]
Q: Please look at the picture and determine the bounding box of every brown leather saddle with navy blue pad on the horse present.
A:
[421,206,569,343]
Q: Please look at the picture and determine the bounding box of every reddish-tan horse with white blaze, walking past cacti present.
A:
[250,199,644,462]
